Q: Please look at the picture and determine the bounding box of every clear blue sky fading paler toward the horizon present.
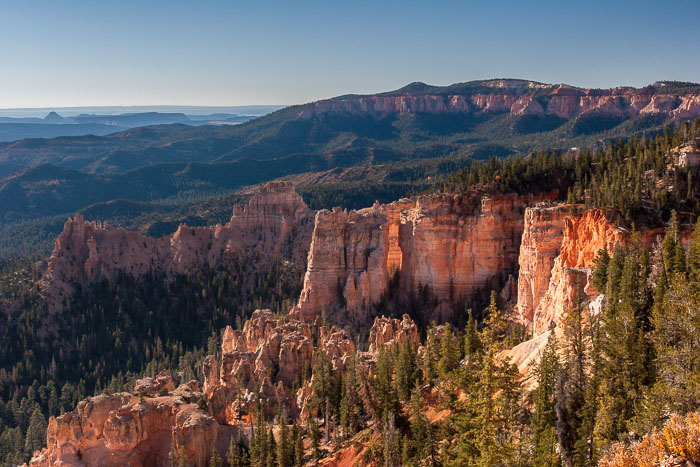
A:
[0,0,700,108]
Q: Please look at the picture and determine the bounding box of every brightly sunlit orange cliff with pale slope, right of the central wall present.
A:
[503,209,628,389]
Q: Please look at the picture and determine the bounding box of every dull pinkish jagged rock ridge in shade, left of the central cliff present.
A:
[45,182,314,309]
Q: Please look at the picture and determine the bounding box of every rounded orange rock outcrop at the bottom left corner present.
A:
[29,374,218,466]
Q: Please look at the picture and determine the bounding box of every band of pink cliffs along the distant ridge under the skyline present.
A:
[299,80,700,120]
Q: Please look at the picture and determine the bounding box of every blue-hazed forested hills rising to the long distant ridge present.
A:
[0,80,700,258]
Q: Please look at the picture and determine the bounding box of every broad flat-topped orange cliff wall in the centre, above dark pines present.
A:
[296,195,548,324]
